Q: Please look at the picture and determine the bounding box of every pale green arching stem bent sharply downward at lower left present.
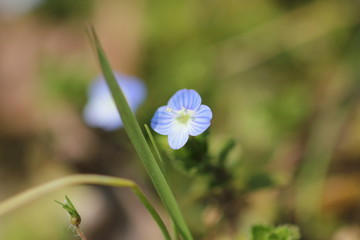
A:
[0,174,171,240]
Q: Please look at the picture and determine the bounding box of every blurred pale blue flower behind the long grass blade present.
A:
[83,72,147,131]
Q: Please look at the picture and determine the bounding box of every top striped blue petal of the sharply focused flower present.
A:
[168,89,201,110]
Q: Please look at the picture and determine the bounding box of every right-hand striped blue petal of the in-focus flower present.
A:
[189,105,212,136]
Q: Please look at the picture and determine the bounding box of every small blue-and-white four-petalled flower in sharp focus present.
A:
[151,89,212,149]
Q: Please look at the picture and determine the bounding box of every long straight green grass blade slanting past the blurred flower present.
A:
[88,27,193,240]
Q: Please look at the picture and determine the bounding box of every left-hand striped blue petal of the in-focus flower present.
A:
[151,106,176,135]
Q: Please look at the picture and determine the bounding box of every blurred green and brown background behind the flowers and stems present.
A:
[0,0,360,240]
